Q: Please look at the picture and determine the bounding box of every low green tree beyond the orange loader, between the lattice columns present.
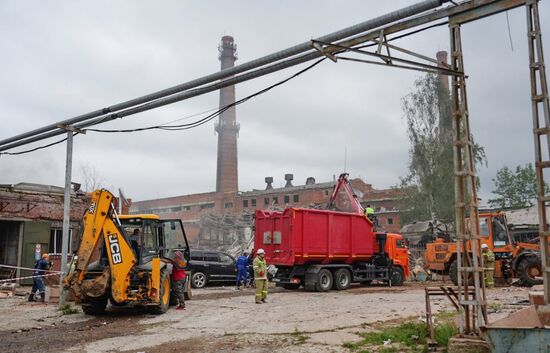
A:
[489,163,548,208]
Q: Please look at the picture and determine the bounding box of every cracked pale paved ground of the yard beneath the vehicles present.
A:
[0,284,528,353]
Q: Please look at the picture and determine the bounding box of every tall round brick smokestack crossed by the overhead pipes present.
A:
[216,36,239,193]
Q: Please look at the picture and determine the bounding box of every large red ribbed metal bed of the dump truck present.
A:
[254,208,378,266]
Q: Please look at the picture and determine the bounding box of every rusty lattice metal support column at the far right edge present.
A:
[526,0,550,304]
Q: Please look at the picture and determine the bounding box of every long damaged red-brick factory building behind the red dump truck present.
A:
[130,174,401,248]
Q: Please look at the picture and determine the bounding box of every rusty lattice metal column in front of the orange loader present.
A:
[449,22,487,334]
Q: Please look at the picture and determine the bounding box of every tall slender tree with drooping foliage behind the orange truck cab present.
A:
[399,74,486,224]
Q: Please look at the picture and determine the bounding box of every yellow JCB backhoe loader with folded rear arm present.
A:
[64,190,190,315]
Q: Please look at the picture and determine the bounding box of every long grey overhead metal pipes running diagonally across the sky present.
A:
[0,0,449,150]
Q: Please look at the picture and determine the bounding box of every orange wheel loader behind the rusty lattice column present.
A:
[424,212,542,286]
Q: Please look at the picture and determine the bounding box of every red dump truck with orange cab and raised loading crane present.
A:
[254,174,409,292]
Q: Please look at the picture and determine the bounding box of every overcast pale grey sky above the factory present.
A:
[0,0,550,203]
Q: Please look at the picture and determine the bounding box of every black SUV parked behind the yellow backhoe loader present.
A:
[187,250,237,288]
